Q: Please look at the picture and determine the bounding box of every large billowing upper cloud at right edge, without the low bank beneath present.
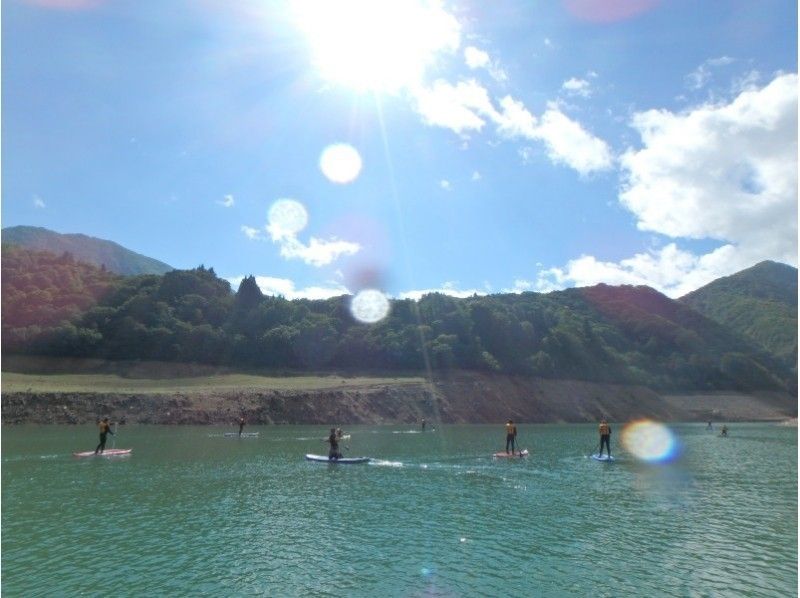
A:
[620,74,797,254]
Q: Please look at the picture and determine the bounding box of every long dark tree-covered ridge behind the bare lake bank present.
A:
[2,247,792,390]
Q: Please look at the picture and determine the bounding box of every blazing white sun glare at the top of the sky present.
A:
[293,0,460,93]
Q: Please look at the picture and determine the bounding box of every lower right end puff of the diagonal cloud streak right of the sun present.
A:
[536,103,614,175]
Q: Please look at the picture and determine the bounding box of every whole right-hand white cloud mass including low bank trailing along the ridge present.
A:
[535,74,798,297]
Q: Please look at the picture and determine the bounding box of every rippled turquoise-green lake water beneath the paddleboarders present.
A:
[2,424,797,597]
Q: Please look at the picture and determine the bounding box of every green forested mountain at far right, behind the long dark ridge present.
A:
[680,261,797,371]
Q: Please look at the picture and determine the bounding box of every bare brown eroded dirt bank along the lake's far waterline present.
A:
[2,373,797,424]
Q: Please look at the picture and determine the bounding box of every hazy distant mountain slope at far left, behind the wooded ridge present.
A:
[2,226,173,275]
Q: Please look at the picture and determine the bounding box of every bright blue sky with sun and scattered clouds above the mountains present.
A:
[2,0,797,298]
